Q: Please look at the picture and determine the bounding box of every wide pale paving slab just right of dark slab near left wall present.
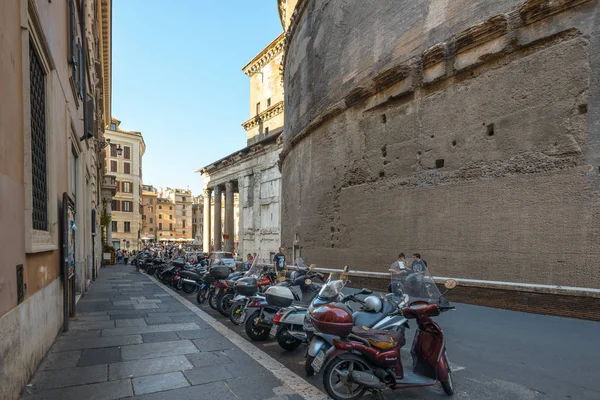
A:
[108,356,194,380]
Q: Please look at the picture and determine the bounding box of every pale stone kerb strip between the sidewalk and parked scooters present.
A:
[144,274,329,400]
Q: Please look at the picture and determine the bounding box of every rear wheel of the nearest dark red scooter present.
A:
[323,353,371,400]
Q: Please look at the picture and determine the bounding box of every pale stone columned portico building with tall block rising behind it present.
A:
[198,34,285,261]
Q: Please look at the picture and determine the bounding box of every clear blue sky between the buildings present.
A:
[112,0,282,194]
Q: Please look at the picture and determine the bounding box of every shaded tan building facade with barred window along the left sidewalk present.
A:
[0,0,111,399]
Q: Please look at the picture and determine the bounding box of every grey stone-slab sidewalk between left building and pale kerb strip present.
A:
[22,265,304,400]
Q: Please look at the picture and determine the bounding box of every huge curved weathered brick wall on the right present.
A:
[278,0,600,294]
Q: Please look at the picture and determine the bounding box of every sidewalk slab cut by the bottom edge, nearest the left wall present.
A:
[23,379,133,400]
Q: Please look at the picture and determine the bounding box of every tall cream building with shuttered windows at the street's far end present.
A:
[104,118,146,251]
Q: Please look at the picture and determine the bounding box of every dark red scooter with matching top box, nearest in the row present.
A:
[311,275,456,400]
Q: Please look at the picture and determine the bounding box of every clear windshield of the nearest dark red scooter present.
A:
[390,260,442,303]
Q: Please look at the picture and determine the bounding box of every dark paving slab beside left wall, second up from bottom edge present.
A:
[30,365,108,393]
